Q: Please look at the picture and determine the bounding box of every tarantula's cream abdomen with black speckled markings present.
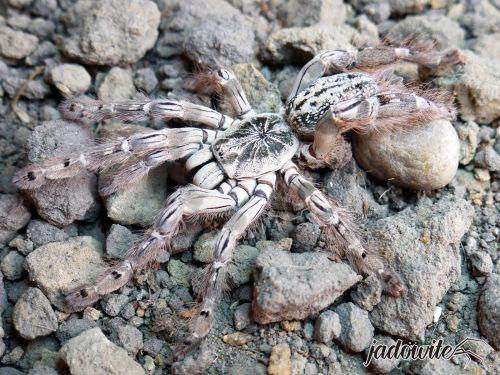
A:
[285,73,378,140]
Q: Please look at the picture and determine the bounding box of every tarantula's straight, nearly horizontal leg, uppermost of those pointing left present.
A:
[59,98,233,129]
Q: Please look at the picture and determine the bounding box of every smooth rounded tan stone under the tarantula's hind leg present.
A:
[353,120,460,190]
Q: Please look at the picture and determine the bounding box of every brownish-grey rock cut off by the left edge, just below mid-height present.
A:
[0,194,31,245]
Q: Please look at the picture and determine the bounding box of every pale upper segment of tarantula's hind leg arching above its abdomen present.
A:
[287,50,356,103]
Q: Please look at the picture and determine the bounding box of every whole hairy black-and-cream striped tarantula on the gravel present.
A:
[14,46,459,352]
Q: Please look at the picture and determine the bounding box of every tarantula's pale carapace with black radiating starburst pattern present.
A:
[212,113,299,179]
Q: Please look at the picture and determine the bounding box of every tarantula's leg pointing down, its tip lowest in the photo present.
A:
[176,173,276,356]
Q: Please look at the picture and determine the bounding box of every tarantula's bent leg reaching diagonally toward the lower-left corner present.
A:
[65,185,236,311]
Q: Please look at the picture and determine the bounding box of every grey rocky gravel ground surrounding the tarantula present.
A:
[0,0,500,375]
